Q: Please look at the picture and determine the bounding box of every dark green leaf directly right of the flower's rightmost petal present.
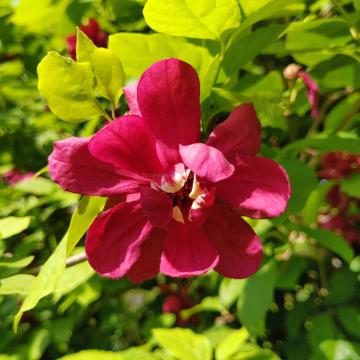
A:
[281,159,318,213]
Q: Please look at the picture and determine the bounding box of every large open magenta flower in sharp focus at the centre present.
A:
[49,59,290,282]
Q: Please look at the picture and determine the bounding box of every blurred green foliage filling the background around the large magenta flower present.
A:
[0,0,360,360]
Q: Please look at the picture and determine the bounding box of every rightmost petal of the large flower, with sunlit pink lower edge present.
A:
[216,157,291,219]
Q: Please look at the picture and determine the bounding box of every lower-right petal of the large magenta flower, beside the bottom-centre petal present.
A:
[204,205,262,279]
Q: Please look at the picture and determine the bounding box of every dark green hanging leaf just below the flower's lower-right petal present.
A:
[237,261,277,335]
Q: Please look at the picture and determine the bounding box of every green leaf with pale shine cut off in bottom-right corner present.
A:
[319,340,360,360]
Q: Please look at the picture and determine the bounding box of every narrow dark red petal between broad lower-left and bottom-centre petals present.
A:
[126,229,166,283]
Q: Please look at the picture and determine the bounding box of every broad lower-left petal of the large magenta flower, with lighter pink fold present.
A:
[85,202,153,279]
